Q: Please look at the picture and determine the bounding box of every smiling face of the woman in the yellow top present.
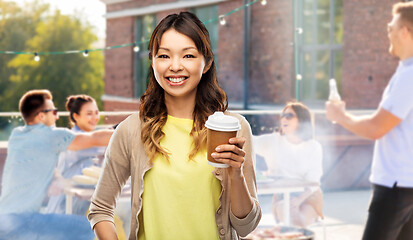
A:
[152,29,209,100]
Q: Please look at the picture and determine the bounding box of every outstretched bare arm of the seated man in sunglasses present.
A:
[67,129,114,150]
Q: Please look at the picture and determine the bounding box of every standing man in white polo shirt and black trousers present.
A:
[326,2,413,240]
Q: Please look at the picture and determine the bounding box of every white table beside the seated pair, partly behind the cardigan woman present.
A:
[63,184,131,214]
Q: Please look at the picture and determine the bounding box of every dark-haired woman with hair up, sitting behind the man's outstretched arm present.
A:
[47,94,106,215]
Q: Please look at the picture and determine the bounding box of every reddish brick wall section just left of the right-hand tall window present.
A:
[248,0,294,104]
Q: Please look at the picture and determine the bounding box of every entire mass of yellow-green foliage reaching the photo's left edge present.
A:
[0,0,104,114]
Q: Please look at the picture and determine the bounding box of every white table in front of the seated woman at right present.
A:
[257,177,320,225]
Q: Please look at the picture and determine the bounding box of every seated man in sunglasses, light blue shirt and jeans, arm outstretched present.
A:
[0,90,113,239]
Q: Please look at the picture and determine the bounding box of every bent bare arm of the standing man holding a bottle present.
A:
[326,101,402,140]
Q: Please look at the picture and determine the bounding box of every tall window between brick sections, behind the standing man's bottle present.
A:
[295,0,343,105]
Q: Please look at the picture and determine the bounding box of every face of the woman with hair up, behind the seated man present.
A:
[73,101,100,132]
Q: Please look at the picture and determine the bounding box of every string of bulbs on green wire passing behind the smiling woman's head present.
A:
[0,0,267,56]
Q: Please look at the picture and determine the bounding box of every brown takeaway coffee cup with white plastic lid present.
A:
[205,112,241,168]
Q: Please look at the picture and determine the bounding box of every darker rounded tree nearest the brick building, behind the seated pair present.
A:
[5,11,104,113]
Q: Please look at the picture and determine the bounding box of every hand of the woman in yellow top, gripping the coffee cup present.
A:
[211,137,245,174]
